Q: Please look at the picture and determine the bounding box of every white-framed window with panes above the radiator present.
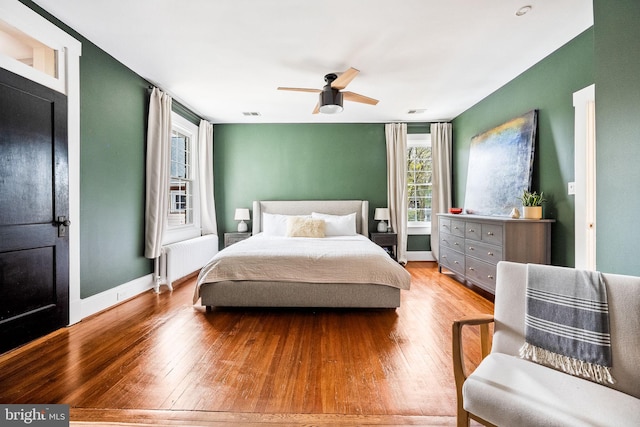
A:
[164,113,200,244]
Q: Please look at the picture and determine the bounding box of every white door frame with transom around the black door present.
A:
[0,0,82,325]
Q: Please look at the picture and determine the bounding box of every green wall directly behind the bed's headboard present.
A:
[213,124,387,239]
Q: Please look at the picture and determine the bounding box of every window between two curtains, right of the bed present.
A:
[407,133,433,234]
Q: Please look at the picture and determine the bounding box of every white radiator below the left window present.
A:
[155,234,218,292]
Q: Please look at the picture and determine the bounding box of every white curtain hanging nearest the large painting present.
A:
[431,123,452,260]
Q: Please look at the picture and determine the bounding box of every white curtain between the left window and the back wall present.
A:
[198,120,218,236]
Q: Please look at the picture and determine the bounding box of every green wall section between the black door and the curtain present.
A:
[80,40,153,298]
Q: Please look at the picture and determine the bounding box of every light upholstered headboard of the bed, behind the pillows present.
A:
[253,200,369,236]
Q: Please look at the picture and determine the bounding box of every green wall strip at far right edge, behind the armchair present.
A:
[594,0,640,276]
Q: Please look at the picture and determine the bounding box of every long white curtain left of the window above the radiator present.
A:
[144,88,172,259]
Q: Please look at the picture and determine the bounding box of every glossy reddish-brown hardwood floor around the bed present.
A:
[0,262,493,426]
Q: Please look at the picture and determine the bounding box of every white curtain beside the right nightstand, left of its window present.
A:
[385,123,407,265]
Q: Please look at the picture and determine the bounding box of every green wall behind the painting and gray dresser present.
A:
[453,28,594,266]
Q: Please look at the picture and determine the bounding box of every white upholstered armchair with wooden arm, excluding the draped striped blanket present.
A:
[453,261,640,427]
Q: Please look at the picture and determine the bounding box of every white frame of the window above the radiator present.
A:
[162,112,202,245]
